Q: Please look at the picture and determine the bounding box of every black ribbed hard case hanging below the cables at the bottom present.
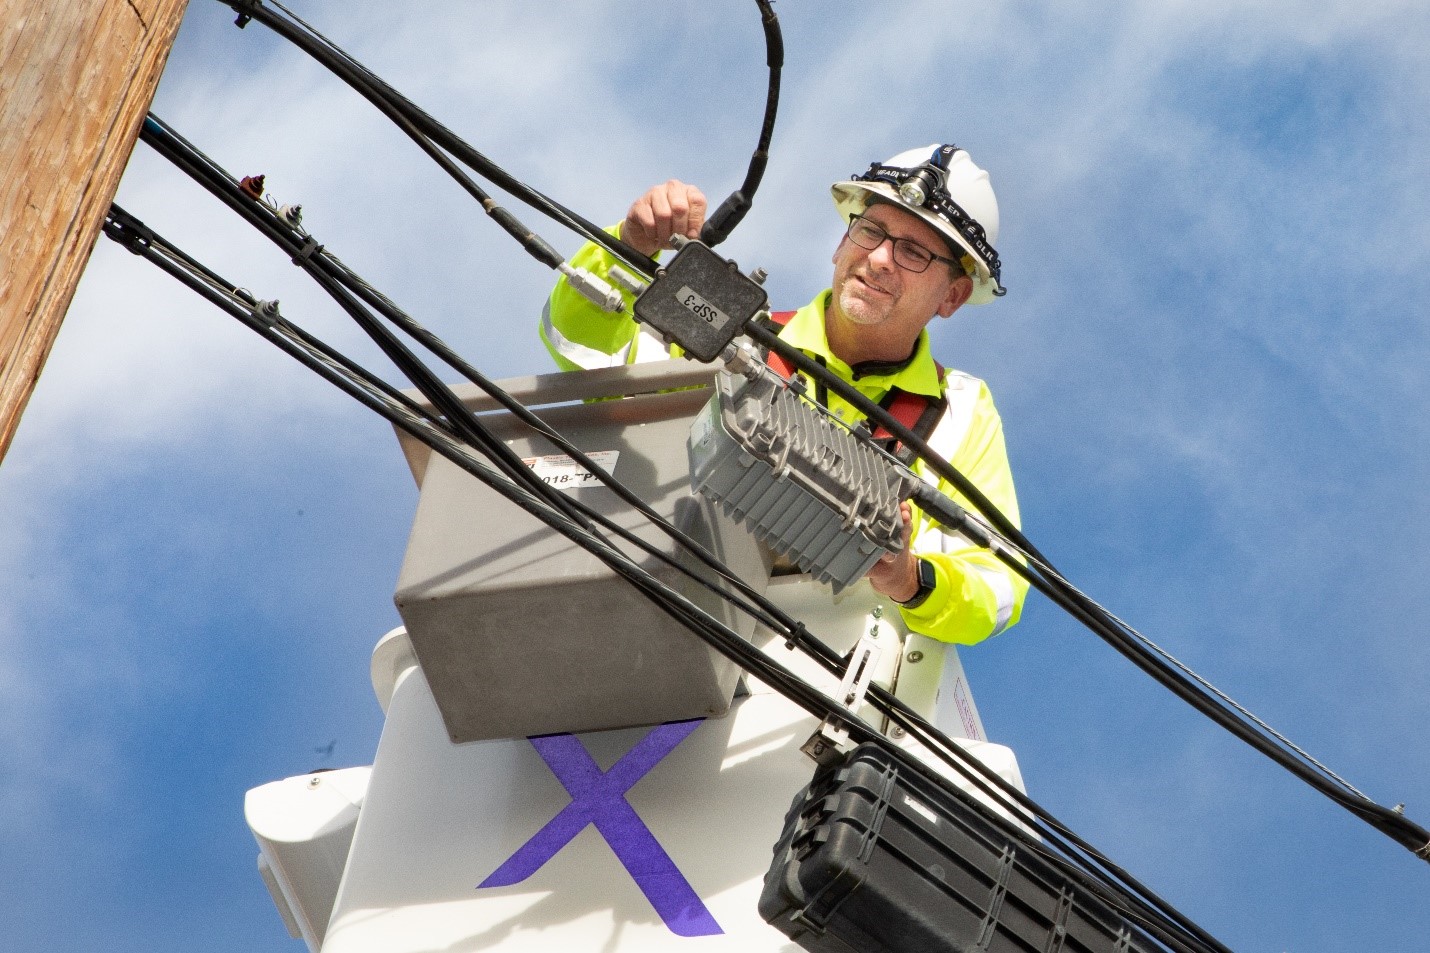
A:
[759,744,1167,953]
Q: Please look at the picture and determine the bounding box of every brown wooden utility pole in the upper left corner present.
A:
[0,0,189,459]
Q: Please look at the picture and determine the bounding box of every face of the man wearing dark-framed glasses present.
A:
[829,205,972,359]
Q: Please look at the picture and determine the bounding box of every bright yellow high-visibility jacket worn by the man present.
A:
[541,231,1028,645]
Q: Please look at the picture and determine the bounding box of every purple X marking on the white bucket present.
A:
[478,718,724,936]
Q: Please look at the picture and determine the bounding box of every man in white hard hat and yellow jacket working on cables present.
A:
[541,146,1027,644]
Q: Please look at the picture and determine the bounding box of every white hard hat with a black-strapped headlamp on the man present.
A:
[831,143,1004,305]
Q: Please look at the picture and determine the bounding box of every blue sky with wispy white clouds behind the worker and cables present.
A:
[0,0,1430,953]
